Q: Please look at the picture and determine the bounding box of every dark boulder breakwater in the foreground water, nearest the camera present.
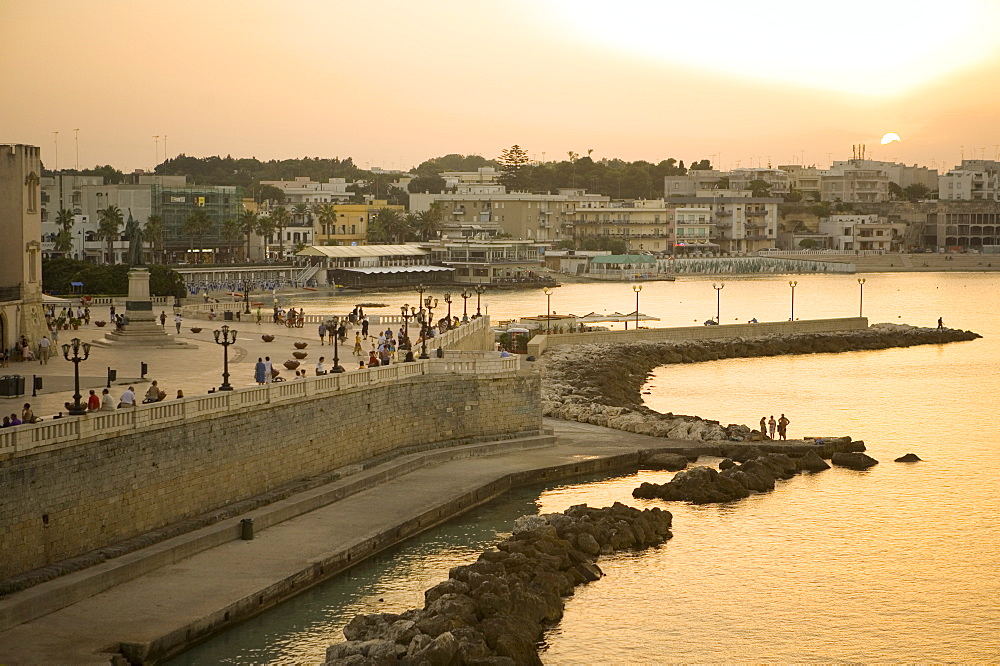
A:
[326,502,672,665]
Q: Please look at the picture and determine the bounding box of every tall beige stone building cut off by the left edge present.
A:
[0,143,47,350]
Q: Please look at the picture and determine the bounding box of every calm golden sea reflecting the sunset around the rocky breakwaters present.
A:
[172,273,1000,664]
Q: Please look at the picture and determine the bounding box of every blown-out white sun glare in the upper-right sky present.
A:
[544,0,1000,95]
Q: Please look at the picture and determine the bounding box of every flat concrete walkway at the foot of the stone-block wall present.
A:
[0,419,708,664]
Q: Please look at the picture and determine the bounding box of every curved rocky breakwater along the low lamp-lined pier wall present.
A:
[537,324,981,441]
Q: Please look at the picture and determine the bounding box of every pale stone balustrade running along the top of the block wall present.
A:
[0,348,520,456]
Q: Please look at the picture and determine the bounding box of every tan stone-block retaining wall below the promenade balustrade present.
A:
[0,372,542,577]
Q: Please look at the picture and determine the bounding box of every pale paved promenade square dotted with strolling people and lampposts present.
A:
[0,306,398,419]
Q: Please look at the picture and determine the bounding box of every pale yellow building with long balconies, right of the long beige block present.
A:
[567,199,675,254]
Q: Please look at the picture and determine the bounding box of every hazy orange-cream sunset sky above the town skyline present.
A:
[0,0,1000,170]
